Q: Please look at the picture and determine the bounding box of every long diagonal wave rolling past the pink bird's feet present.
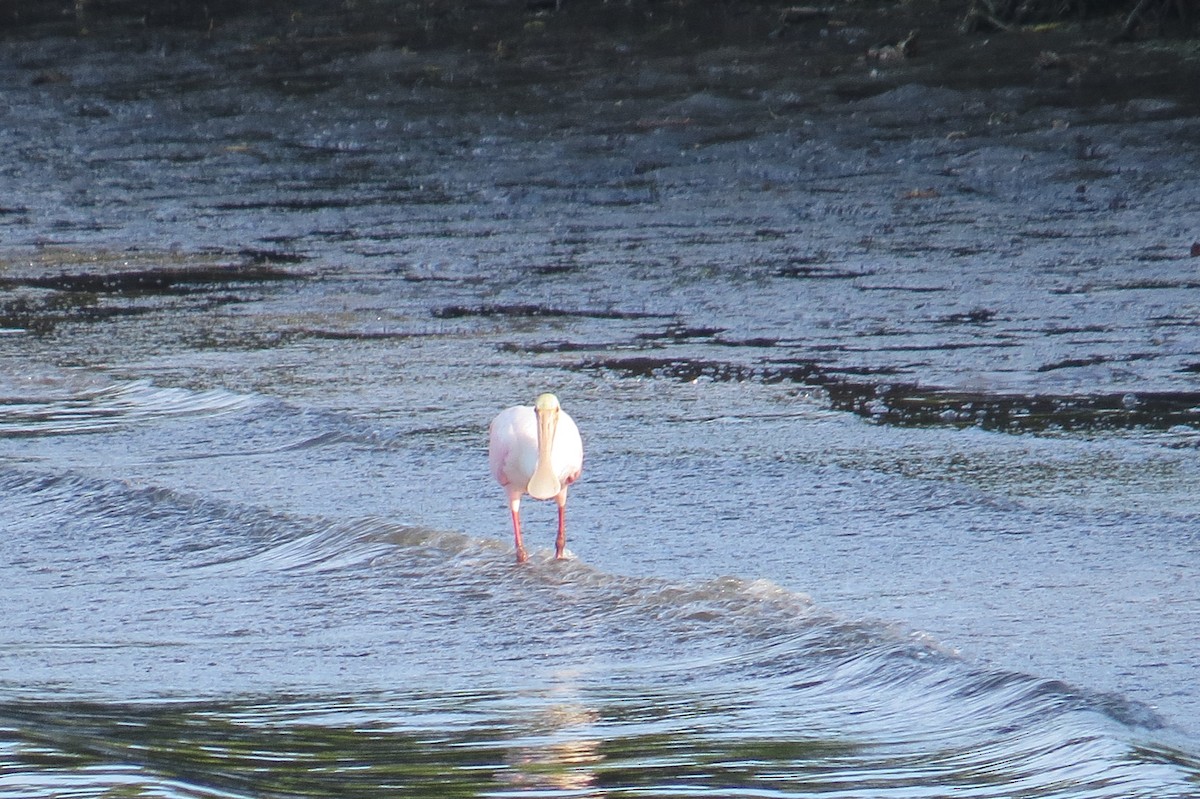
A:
[25,473,1163,734]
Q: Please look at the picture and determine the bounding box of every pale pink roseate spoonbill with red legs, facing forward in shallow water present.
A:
[487,394,583,563]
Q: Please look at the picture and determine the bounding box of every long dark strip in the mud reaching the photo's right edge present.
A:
[578,355,1200,433]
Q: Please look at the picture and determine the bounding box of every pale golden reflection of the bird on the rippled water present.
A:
[499,674,604,797]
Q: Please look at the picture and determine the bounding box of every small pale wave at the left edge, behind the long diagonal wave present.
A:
[0,378,260,437]
